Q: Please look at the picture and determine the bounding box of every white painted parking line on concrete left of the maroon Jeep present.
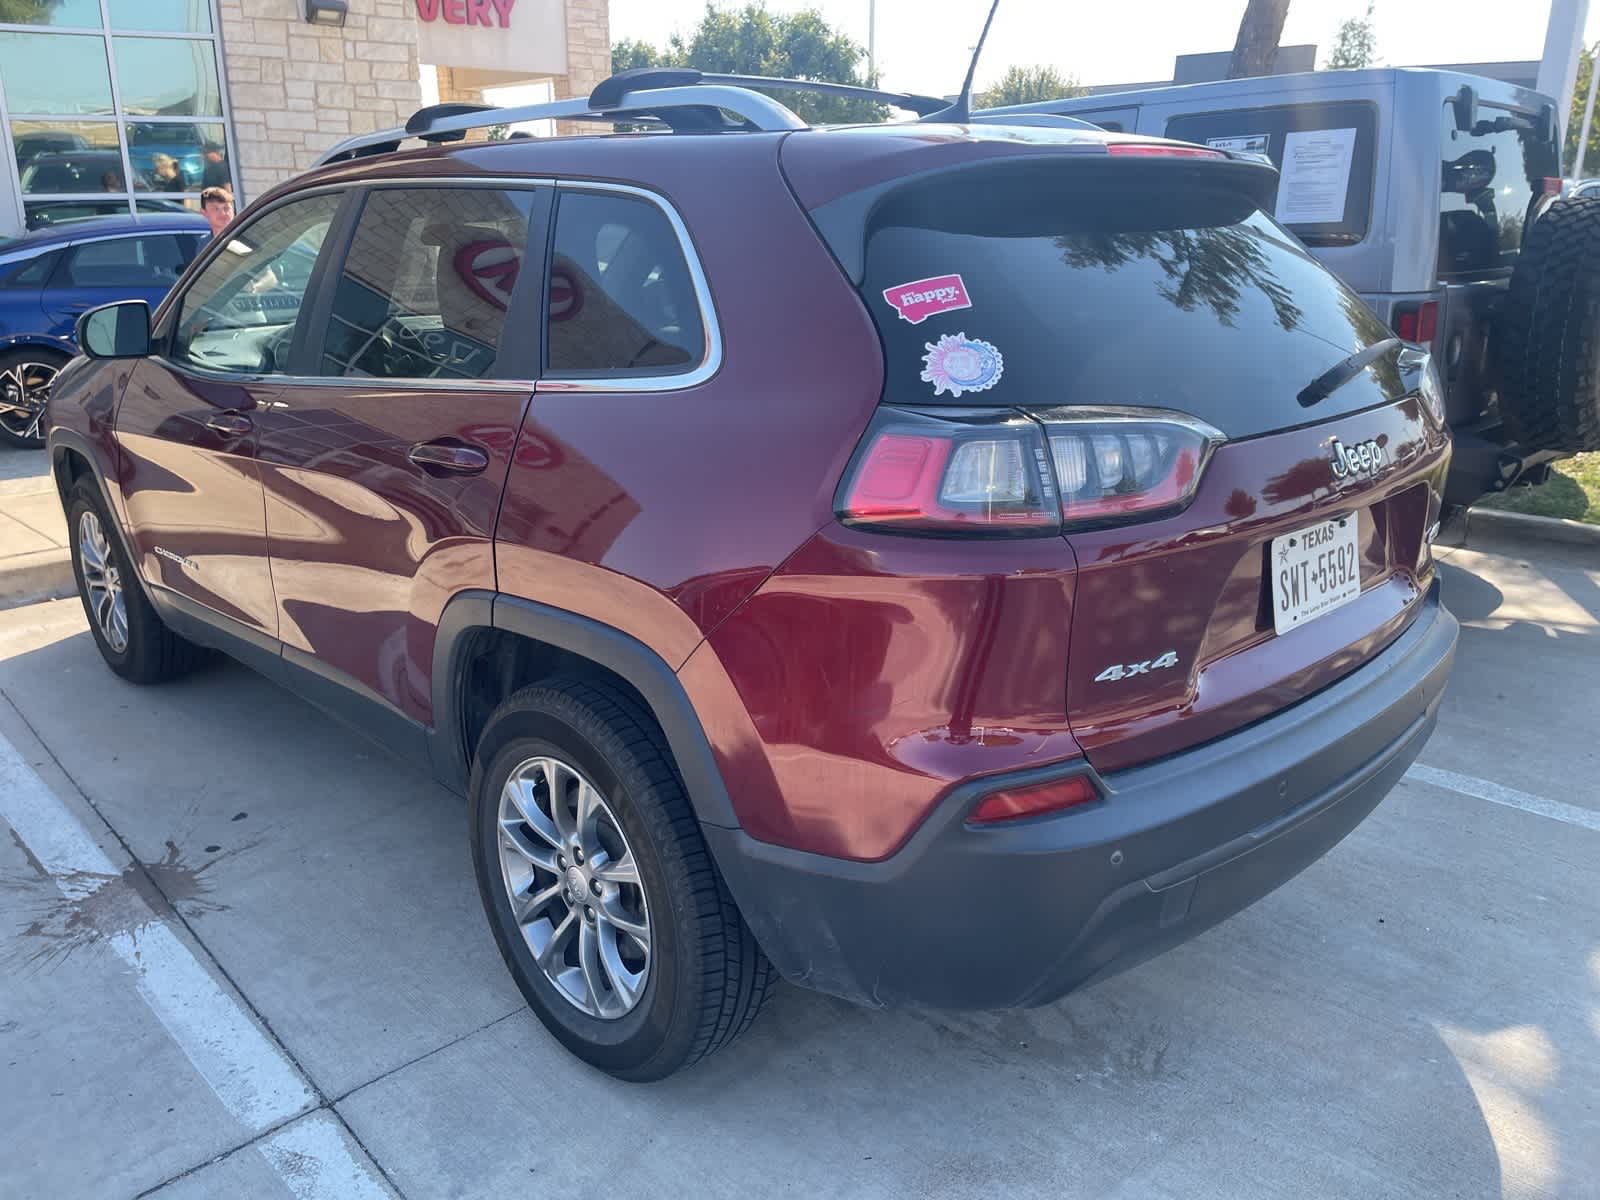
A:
[0,736,390,1200]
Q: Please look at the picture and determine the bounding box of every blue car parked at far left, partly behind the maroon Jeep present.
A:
[0,213,210,446]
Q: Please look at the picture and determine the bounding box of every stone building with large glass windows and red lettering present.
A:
[0,0,611,235]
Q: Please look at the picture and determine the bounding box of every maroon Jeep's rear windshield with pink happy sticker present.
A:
[861,163,1402,438]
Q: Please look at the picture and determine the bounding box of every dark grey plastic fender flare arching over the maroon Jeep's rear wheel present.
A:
[429,590,739,829]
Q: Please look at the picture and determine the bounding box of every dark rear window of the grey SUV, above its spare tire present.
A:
[1438,104,1557,277]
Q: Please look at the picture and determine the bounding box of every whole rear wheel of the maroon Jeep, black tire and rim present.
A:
[470,678,774,1082]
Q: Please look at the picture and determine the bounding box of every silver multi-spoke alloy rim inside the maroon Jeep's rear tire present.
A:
[499,757,651,1021]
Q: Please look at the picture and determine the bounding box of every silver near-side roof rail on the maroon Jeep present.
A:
[314,80,806,166]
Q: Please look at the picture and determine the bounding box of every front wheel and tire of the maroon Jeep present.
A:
[66,480,208,683]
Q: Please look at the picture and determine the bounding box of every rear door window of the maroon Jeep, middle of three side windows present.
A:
[322,187,533,379]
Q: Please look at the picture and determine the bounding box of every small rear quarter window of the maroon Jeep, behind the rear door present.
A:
[546,192,706,376]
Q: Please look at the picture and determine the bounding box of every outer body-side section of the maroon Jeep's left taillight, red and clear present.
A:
[838,408,1061,536]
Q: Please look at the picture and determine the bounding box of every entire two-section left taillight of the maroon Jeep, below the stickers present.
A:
[837,408,1222,538]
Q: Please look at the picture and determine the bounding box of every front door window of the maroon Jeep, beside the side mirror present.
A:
[170,195,339,374]
